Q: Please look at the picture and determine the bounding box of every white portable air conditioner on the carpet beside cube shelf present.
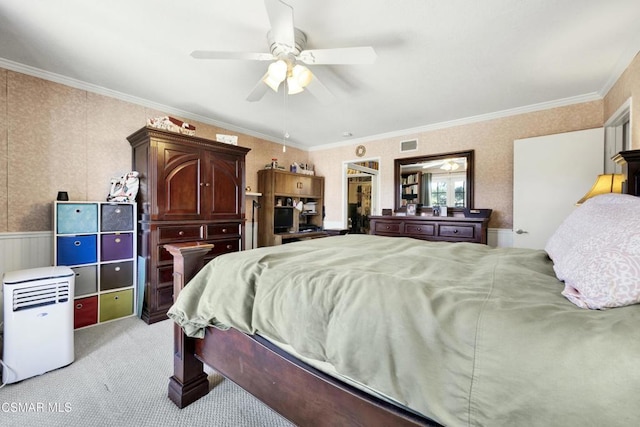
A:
[2,266,75,384]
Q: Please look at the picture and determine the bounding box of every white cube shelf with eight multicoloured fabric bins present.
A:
[53,201,137,329]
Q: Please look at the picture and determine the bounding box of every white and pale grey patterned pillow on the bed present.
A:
[545,194,640,309]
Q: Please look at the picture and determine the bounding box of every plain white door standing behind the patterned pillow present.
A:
[513,128,604,249]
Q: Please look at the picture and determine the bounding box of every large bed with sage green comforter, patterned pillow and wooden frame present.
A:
[168,152,640,426]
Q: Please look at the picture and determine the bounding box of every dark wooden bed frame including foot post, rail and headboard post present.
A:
[165,150,640,427]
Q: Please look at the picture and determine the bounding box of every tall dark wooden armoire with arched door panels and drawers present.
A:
[127,127,250,323]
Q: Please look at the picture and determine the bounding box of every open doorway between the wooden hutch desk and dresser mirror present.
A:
[343,159,380,234]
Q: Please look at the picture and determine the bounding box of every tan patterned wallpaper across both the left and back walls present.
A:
[0,51,640,232]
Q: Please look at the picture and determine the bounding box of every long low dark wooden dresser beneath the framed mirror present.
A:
[370,216,489,244]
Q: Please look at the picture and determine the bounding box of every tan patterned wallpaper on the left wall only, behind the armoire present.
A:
[0,69,308,232]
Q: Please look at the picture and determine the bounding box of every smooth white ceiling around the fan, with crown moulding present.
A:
[0,0,640,148]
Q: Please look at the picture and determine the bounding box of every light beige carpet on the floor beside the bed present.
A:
[0,317,291,427]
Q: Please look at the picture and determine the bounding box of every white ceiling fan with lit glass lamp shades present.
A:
[191,0,376,104]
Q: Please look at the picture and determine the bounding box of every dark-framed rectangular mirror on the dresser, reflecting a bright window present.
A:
[394,150,473,212]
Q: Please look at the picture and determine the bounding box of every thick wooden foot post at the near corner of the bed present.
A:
[164,242,213,408]
